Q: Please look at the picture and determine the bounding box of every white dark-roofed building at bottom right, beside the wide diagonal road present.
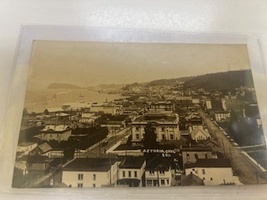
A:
[185,159,241,185]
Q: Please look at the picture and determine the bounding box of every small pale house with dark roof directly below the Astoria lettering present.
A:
[145,156,174,187]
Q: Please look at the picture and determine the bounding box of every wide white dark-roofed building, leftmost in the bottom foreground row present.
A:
[62,158,118,188]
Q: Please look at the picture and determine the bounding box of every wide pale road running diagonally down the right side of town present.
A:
[199,110,267,184]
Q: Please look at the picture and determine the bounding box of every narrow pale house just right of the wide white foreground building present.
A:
[117,156,146,187]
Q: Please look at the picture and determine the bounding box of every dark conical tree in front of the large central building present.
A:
[143,122,158,148]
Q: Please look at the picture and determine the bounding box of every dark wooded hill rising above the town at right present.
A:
[184,70,254,90]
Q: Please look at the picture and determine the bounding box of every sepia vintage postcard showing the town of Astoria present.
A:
[13,40,267,188]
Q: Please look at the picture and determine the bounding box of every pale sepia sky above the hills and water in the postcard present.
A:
[28,41,250,88]
